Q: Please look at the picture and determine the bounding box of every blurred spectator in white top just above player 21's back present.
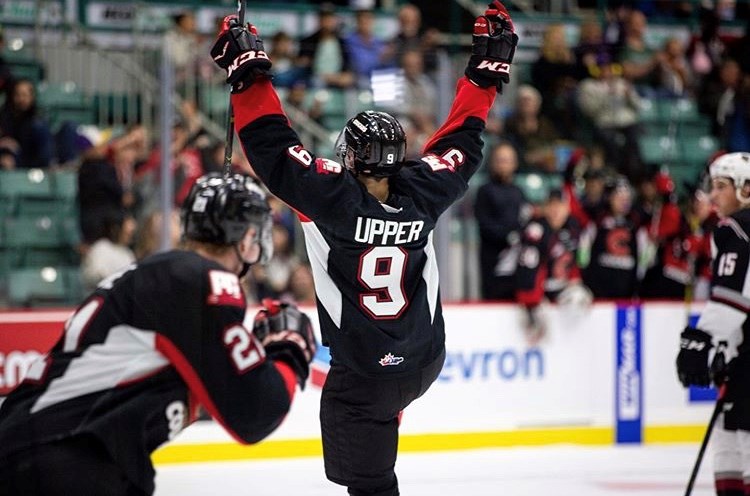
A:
[81,211,136,292]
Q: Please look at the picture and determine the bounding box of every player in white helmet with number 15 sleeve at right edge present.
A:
[677,152,750,496]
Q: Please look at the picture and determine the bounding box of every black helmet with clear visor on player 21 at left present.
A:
[182,172,273,262]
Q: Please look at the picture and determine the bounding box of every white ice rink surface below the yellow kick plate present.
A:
[156,444,713,496]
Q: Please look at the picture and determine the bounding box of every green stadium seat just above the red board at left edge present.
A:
[8,267,70,306]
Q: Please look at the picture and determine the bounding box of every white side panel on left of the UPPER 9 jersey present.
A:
[301,222,343,329]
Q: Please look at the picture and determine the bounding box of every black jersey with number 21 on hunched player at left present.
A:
[0,251,295,493]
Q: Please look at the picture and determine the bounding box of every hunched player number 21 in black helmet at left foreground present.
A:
[0,175,315,496]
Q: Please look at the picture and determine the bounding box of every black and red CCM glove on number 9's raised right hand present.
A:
[465,0,518,90]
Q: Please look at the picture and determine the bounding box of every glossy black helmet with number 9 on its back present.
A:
[335,110,406,177]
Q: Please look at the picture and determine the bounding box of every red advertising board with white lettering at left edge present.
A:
[0,310,72,396]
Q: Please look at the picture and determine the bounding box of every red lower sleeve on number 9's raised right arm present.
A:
[422,76,497,153]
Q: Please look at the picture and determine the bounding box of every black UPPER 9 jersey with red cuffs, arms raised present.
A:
[232,78,495,377]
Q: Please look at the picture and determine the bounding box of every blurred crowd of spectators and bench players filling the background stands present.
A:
[0,4,750,308]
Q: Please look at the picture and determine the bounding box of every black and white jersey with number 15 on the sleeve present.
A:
[696,209,750,352]
